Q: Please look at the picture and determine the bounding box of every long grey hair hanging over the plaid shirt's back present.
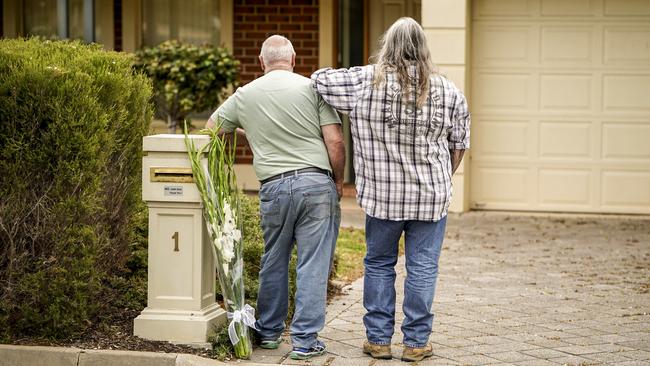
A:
[373,17,436,107]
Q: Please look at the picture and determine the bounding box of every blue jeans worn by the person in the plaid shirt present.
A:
[363,215,447,348]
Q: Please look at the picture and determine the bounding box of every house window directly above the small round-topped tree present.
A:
[142,0,220,46]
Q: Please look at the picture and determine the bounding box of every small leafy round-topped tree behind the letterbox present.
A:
[134,41,239,133]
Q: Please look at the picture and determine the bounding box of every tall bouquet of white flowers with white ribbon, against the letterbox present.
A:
[185,124,255,359]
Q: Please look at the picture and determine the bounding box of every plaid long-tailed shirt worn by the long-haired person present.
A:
[312,65,470,221]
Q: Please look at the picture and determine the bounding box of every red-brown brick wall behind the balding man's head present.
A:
[233,0,318,164]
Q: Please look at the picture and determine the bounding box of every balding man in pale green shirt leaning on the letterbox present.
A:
[207,35,345,359]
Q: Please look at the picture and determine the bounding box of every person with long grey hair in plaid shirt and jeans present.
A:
[311,18,470,361]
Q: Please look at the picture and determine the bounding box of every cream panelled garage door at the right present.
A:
[470,0,650,214]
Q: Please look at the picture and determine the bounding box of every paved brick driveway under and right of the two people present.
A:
[246,212,650,366]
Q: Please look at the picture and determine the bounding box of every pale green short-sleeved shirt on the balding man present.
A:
[211,70,341,180]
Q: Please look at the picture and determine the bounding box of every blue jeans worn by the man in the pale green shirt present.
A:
[256,173,341,348]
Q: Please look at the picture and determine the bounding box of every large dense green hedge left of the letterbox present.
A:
[0,39,152,340]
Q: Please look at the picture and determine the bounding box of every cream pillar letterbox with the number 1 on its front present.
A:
[133,135,226,344]
